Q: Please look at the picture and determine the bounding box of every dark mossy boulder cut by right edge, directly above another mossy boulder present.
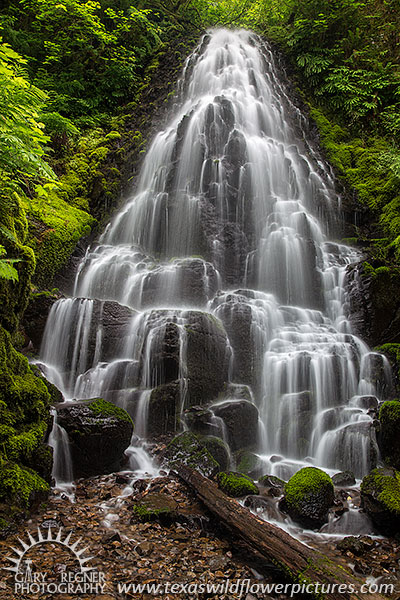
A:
[379,400,400,470]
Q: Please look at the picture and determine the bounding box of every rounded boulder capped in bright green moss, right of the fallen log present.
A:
[281,467,334,529]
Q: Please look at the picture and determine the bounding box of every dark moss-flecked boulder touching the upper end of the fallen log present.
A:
[164,431,220,477]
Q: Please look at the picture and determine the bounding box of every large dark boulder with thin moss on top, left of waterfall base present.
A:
[57,398,133,478]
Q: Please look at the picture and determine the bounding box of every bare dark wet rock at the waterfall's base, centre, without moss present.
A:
[211,400,258,451]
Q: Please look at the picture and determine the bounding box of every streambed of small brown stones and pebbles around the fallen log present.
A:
[0,464,400,600]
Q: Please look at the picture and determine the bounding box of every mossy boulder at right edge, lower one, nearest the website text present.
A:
[361,468,400,535]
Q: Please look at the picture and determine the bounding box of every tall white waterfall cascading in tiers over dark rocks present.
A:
[41,30,390,502]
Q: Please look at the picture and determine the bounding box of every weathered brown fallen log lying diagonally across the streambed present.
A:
[174,464,385,600]
